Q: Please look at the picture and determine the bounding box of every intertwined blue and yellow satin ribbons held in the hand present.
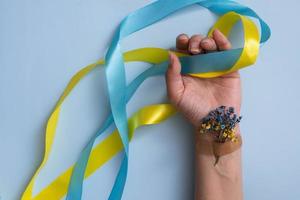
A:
[22,0,270,200]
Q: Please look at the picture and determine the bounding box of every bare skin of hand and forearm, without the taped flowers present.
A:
[166,30,243,200]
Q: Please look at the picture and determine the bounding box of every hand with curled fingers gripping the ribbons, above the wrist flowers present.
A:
[166,30,241,127]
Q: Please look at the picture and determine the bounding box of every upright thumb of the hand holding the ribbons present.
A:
[166,52,184,105]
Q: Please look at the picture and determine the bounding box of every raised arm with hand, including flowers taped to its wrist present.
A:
[166,29,242,200]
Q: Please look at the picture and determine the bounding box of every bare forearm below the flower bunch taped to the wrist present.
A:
[195,129,243,200]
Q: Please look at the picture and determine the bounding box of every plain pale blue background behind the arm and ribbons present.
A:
[0,0,300,200]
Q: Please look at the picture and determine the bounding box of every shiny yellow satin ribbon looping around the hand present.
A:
[22,12,259,200]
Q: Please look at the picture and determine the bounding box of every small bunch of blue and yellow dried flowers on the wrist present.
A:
[199,106,242,143]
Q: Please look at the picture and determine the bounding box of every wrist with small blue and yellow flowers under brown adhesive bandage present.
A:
[196,106,242,165]
